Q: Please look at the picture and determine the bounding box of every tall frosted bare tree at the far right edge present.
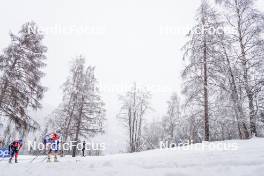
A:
[216,0,264,135]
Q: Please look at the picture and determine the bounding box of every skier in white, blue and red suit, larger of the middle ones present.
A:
[44,133,60,162]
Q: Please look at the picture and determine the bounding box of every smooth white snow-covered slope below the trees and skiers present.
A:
[0,138,264,176]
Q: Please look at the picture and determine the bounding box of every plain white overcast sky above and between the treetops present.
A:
[0,0,264,151]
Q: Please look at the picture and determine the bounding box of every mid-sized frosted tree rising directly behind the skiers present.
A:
[47,56,105,157]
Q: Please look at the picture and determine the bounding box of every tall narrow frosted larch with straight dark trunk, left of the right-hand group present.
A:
[182,1,221,141]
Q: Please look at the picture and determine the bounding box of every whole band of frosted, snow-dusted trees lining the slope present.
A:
[0,0,264,157]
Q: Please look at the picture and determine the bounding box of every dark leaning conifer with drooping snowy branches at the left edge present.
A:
[0,22,47,142]
